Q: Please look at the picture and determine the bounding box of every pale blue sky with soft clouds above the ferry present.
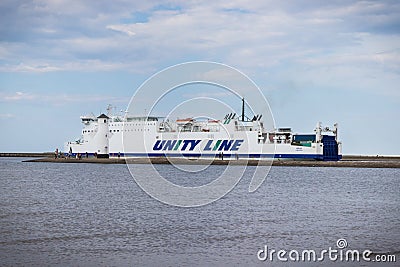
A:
[0,0,400,155]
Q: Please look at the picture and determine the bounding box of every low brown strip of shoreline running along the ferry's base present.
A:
[0,152,400,168]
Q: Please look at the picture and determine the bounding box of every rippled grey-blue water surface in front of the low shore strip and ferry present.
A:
[0,158,400,266]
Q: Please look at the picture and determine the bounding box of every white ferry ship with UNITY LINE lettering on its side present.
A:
[65,99,342,161]
